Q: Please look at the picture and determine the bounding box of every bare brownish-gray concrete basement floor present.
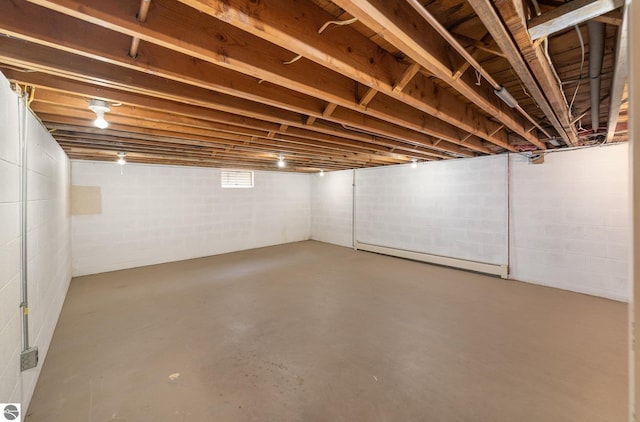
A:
[26,241,627,422]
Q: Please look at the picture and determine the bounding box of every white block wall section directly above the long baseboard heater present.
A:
[356,155,507,265]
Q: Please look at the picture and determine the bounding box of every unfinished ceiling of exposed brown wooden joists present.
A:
[0,0,628,172]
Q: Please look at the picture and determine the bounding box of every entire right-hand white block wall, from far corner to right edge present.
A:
[311,148,631,301]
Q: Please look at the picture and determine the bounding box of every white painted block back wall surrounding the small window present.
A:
[72,161,310,275]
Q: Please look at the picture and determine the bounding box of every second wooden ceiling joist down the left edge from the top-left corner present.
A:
[0,37,464,160]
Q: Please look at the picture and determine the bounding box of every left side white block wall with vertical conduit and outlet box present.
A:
[0,75,71,410]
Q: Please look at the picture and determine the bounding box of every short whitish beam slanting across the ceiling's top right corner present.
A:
[528,0,624,40]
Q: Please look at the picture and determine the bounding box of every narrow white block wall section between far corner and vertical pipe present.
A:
[310,170,353,247]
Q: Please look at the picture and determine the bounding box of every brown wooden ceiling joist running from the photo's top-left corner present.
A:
[0,3,480,154]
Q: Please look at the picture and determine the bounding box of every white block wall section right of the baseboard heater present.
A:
[510,144,631,300]
